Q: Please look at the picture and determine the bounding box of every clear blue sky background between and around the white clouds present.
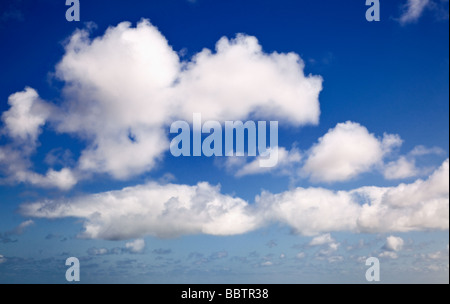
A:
[0,0,449,283]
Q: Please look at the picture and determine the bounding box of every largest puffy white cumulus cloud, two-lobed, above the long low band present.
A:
[48,20,322,178]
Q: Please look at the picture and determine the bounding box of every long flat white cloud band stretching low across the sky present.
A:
[20,160,449,240]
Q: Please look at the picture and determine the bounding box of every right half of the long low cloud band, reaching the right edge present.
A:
[256,160,449,235]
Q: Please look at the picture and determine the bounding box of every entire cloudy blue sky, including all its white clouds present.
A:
[0,0,449,283]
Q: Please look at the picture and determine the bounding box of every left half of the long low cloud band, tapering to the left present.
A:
[21,183,260,240]
